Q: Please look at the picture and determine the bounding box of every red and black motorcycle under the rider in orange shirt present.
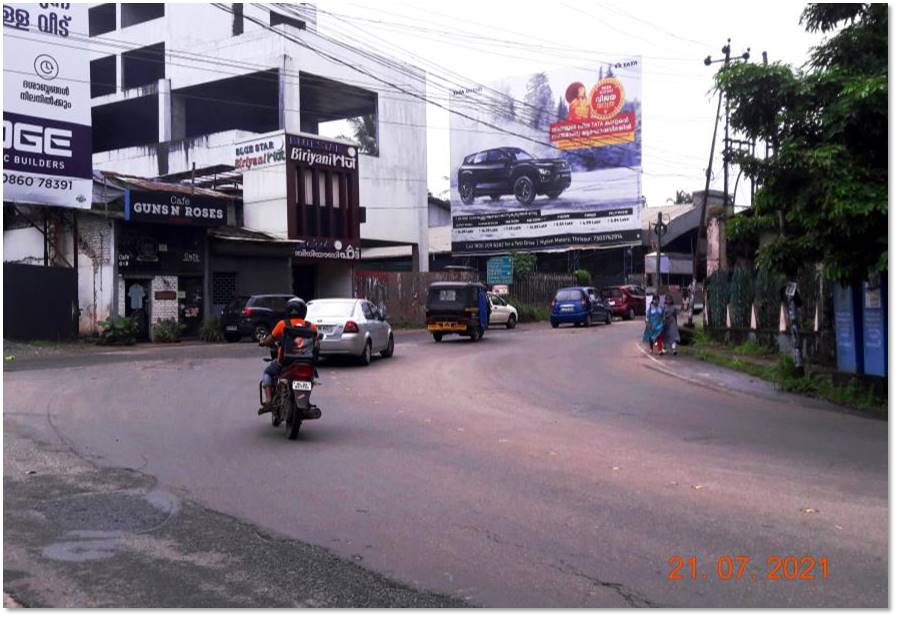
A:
[259,333,321,439]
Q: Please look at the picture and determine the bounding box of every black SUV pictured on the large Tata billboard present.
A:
[458,148,570,206]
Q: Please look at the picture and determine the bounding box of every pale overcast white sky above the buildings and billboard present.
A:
[317,0,822,206]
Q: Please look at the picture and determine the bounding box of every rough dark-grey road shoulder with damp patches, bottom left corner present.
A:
[3,419,464,608]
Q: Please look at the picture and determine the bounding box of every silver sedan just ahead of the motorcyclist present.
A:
[306,298,396,365]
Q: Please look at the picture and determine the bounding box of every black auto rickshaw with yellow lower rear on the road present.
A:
[427,281,490,343]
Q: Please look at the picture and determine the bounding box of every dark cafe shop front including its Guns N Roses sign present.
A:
[116,187,227,340]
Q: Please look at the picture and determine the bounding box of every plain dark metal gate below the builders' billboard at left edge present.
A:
[3,263,78,341]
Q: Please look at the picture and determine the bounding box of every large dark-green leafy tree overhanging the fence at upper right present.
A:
[716,4,888,283]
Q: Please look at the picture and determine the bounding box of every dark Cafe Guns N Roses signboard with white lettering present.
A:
[125,189,227,227]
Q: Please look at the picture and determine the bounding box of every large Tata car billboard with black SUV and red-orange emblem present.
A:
[450,58,642,255]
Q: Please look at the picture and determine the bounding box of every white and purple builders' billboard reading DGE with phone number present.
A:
[3,3,93,208]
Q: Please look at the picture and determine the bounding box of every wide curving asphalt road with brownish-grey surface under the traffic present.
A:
[4,322,888,607]
